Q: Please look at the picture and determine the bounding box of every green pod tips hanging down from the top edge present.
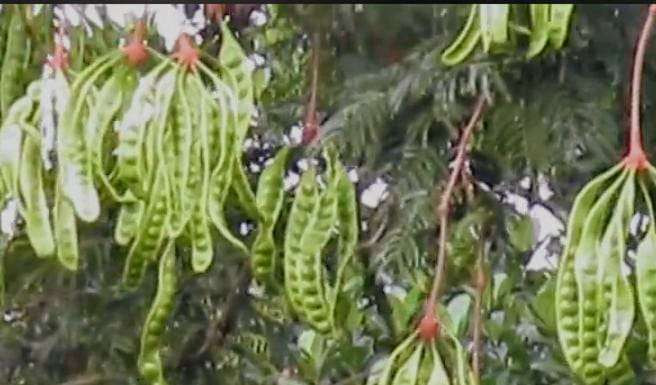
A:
[442,4,574,66]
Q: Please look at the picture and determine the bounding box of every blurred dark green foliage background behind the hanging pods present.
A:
[0,4,656,385]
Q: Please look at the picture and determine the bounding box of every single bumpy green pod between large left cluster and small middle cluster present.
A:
[251,147,289,282]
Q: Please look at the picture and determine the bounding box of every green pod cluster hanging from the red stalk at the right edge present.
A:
[556,158,656,384]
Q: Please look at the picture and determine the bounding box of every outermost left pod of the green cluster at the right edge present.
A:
[555,165,621,378]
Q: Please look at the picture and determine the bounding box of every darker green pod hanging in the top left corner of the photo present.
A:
[0,5,28,119]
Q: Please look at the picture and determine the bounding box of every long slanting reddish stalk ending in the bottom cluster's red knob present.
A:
[419,95,485,340]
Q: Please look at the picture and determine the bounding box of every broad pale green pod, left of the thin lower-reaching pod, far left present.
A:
[19,137,55,257]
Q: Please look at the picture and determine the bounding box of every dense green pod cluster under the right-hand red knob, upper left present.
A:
[112,23,262,287]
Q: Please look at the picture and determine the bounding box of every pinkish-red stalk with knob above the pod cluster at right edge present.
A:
[624,4,656,170]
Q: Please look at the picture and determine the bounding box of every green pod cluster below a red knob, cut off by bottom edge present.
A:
[368,308,477,385]
